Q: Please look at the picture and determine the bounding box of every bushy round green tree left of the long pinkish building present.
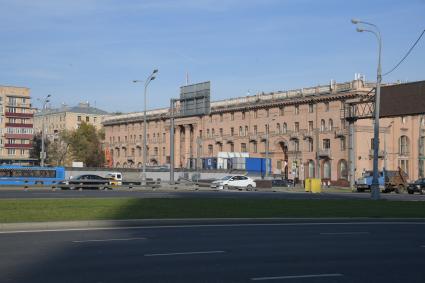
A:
[62,122,105,167]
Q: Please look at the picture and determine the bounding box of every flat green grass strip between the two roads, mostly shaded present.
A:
[0,198,425,223]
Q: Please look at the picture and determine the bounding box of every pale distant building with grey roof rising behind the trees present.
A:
[34,102,109,139]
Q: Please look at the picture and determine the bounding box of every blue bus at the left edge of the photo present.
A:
[0,165,65,185]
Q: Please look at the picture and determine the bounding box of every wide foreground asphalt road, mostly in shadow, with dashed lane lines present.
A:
[0,220,425,283]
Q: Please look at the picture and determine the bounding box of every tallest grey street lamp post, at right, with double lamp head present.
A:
[351,19,382,200]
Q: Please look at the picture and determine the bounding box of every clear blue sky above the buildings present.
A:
[0,0,425,112]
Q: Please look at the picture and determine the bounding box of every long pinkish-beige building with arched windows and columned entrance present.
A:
[103,79,425,185]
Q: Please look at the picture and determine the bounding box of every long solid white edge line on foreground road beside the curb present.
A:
[0,222,425,234]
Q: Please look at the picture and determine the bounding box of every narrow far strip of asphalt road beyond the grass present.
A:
[0,188,425,201]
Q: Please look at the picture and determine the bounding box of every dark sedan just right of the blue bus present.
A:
[59,174,111,190]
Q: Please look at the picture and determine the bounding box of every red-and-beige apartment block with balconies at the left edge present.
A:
[0,85,34,165]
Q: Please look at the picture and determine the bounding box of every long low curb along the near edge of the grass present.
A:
[0,220,425,233]
